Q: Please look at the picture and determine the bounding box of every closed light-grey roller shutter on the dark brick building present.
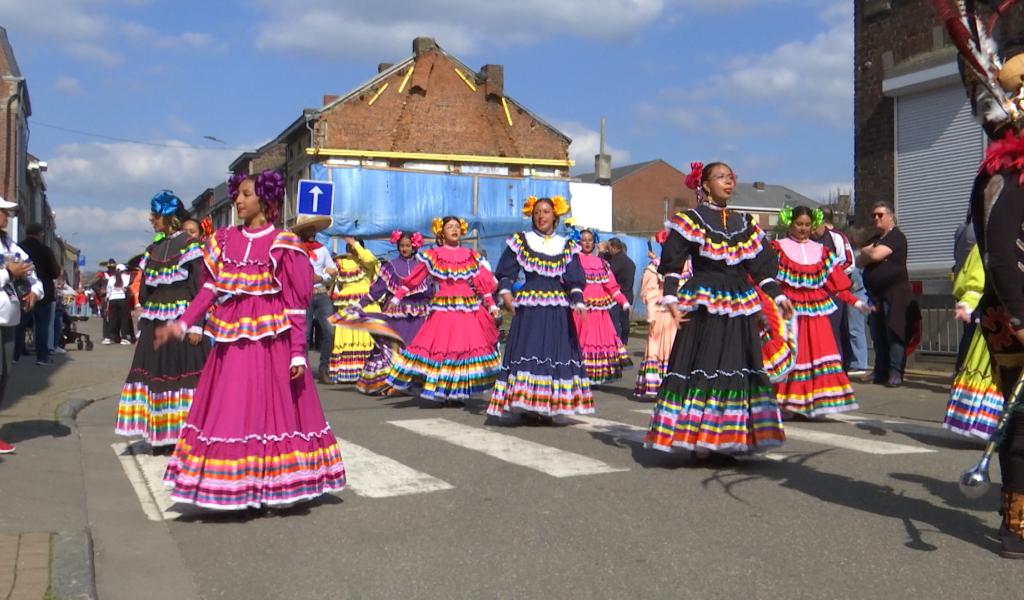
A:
[896,85,985,271]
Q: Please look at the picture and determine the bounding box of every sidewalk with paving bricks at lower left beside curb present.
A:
[0,318,125,600]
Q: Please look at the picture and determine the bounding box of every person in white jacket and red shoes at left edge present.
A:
[0,198,43,455]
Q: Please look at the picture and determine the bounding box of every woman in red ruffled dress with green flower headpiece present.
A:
[772,206,870,419]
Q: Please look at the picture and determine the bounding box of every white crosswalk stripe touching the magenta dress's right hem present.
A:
[338,439,455,498]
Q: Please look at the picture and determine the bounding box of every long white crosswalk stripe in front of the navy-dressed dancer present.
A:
[388,419,629,477]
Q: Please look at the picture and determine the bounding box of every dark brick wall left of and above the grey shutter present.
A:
[854,0,936,225]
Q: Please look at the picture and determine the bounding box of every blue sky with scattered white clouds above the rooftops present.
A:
[0,0,853,266]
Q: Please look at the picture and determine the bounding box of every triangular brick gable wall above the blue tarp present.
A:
[316,50,568,160]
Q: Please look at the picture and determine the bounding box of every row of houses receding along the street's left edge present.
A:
[0,27,80,285]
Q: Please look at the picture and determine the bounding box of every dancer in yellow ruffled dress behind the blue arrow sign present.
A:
[327,238,380,383]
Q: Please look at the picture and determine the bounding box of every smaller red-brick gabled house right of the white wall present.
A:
[580,159,696,237]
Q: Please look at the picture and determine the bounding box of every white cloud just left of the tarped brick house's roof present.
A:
[46,140,239,208]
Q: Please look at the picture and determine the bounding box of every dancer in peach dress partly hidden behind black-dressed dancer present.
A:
[633,229,690,400]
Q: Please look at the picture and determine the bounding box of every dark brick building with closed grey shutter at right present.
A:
[854,0,985,282]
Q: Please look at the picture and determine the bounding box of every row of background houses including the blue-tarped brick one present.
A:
[193,38,814,246]
